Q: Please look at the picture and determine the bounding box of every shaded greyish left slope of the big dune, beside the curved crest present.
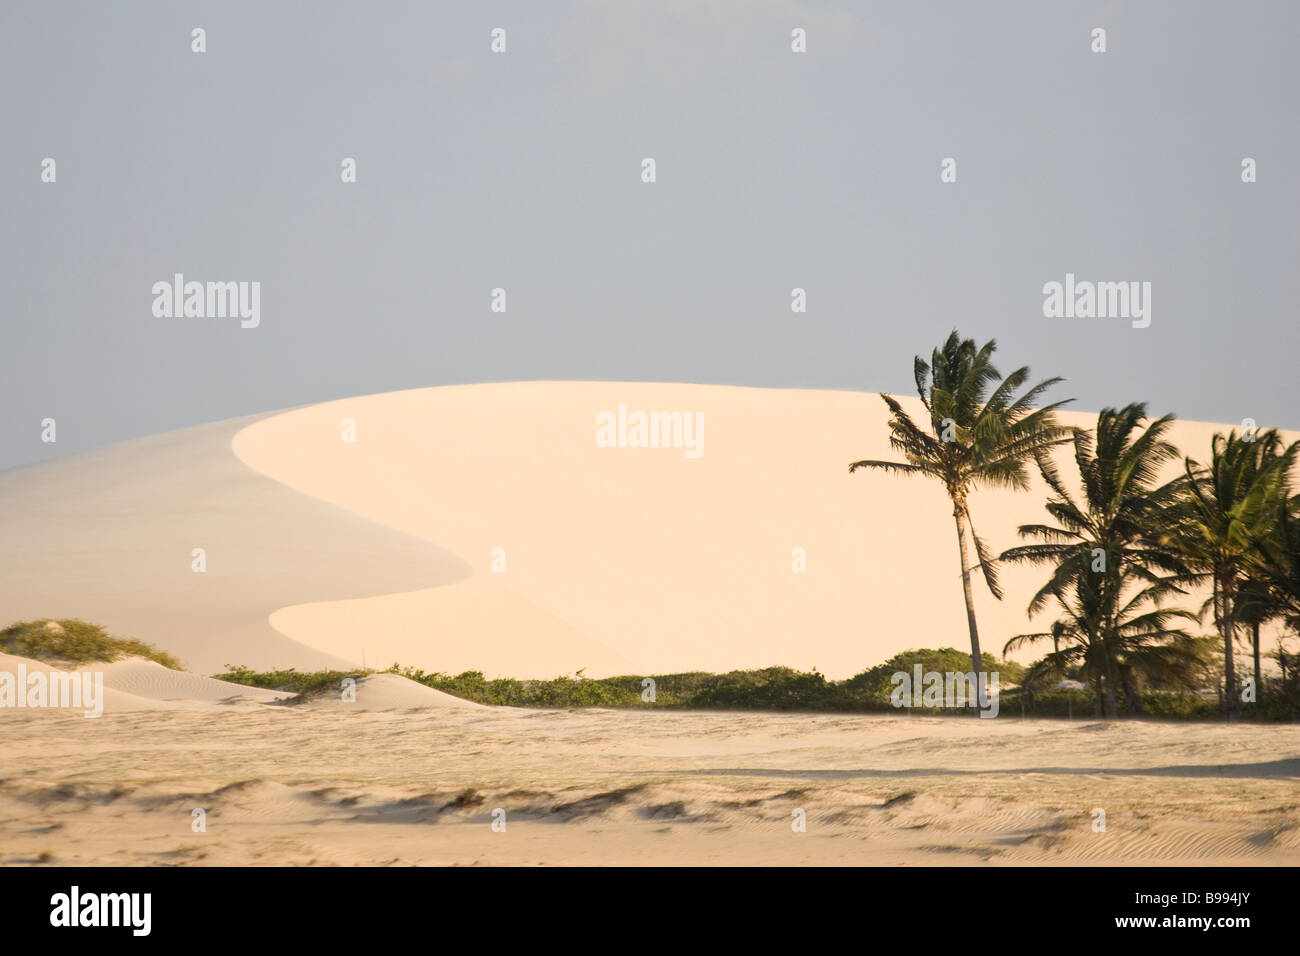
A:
[0,419,468,674]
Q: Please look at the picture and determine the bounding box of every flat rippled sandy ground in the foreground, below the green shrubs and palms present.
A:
[0,698,1300,865]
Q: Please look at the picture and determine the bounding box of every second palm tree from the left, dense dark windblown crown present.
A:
[1000,402,1188,718]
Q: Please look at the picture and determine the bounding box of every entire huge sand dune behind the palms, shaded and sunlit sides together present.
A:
[0,382,1289,678]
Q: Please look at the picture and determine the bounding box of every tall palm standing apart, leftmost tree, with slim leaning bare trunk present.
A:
[849,330,1065,680]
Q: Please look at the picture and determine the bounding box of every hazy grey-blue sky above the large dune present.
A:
[0,0,1300,467]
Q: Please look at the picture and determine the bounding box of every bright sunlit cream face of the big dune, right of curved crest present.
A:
[233,382,1289,678]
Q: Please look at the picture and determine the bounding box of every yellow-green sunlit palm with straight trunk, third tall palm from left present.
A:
[1165,429,1300,721]
